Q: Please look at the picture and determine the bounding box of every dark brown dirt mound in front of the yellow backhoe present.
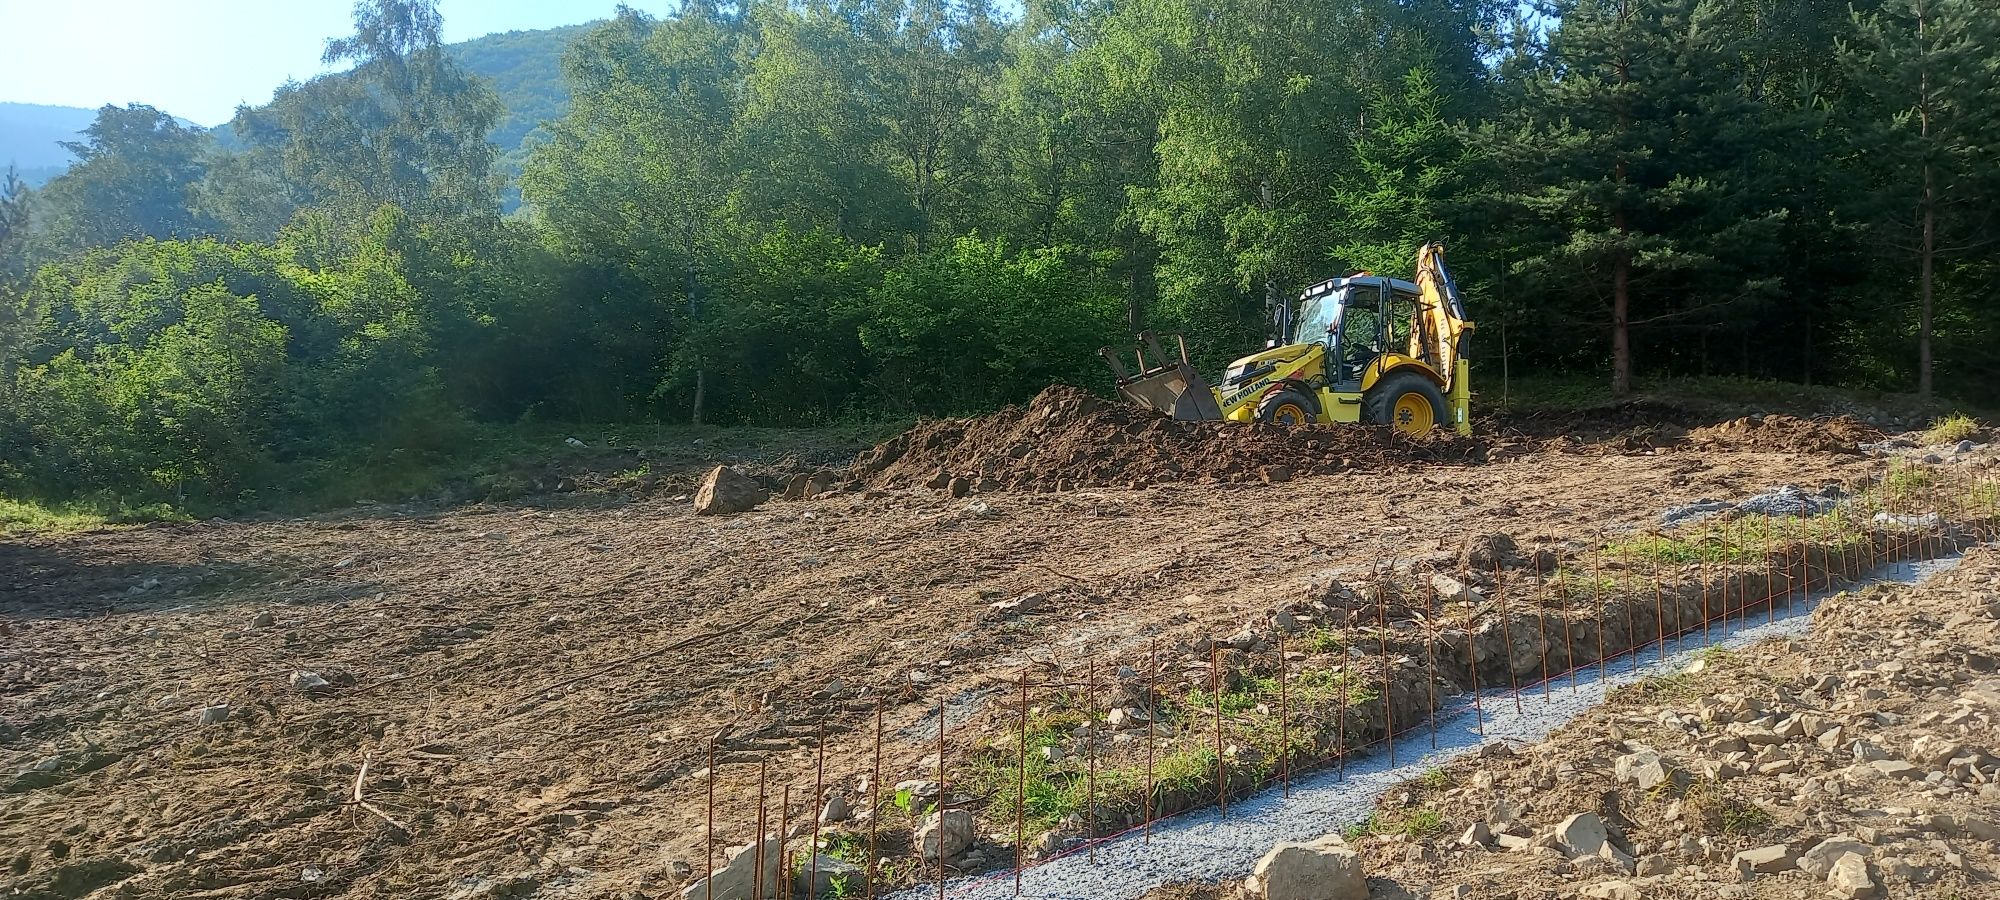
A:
[854,384,1484,492]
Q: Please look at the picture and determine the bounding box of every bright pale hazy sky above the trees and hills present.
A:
[0,0,678,126]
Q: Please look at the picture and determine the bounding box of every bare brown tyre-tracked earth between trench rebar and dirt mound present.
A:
[0,432,1912,898]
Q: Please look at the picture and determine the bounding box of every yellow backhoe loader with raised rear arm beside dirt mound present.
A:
[1100,244,1472,434]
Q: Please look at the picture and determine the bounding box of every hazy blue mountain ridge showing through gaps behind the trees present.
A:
[0,22,596,192]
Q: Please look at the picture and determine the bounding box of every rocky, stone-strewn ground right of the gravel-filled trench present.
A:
[1328,546,2000,900]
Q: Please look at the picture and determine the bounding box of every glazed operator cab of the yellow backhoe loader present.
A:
[1286,274,1428,392]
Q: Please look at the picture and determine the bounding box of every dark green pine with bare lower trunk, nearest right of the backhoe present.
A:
[1482,0,1782,394]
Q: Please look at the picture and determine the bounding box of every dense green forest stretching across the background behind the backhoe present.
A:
[0,0,2000,510]
